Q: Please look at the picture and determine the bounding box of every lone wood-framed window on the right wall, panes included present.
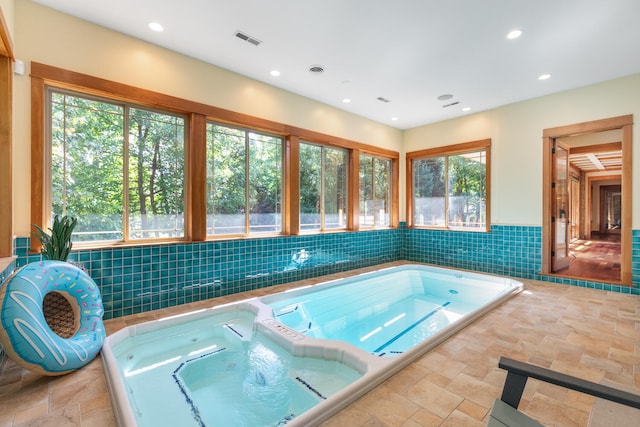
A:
[407,140,491,231]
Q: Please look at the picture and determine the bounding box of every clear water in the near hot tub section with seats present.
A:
[107,310,363,427]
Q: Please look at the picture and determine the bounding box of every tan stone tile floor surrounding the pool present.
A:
[0,263,640,427]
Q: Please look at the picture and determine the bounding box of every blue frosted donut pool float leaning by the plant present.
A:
[0,261,106,375]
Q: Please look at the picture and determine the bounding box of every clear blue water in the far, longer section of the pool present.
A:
[262,268,502,357]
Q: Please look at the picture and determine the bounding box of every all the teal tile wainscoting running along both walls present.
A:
[0,224,640,319]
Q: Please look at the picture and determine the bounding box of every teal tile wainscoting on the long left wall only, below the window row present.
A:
[8,229,401,319]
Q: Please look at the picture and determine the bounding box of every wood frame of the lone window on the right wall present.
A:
[405,138,491,232]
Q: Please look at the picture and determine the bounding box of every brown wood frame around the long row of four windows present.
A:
[31,62,399,252]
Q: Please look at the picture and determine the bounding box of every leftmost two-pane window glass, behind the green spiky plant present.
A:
[46,90,185,242]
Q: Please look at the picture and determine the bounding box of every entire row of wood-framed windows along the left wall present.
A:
[30,62,399,252]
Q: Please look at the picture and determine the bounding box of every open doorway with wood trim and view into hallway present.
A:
[542,115,633,284]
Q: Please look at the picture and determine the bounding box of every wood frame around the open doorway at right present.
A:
[541,114,633,285]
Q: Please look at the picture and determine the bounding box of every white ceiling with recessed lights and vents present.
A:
[33,0,640,129]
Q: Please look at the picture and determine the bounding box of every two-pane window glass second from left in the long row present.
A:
[207,122,283,235]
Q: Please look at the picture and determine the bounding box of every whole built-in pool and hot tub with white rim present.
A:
[102,265,522,427]
